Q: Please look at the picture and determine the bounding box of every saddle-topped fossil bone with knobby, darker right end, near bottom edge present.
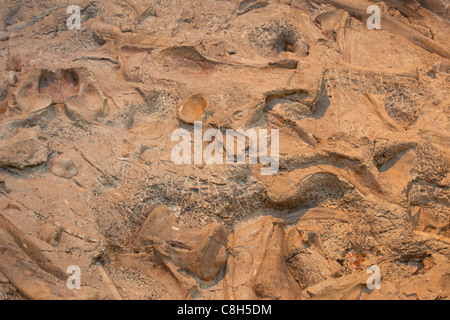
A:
[118,205,228,299]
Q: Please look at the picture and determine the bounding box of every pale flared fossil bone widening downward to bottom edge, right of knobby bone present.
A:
[219,216,301,300]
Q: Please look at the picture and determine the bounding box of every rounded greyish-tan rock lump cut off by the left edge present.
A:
[0,127,50,170]
